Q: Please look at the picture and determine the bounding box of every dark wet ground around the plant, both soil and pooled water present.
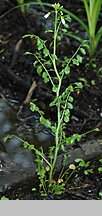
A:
[0,0,102,199]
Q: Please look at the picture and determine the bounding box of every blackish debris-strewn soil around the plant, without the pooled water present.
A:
[0,0,102,200]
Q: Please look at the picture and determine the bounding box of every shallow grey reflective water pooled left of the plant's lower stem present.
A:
[0,99,53,192]
